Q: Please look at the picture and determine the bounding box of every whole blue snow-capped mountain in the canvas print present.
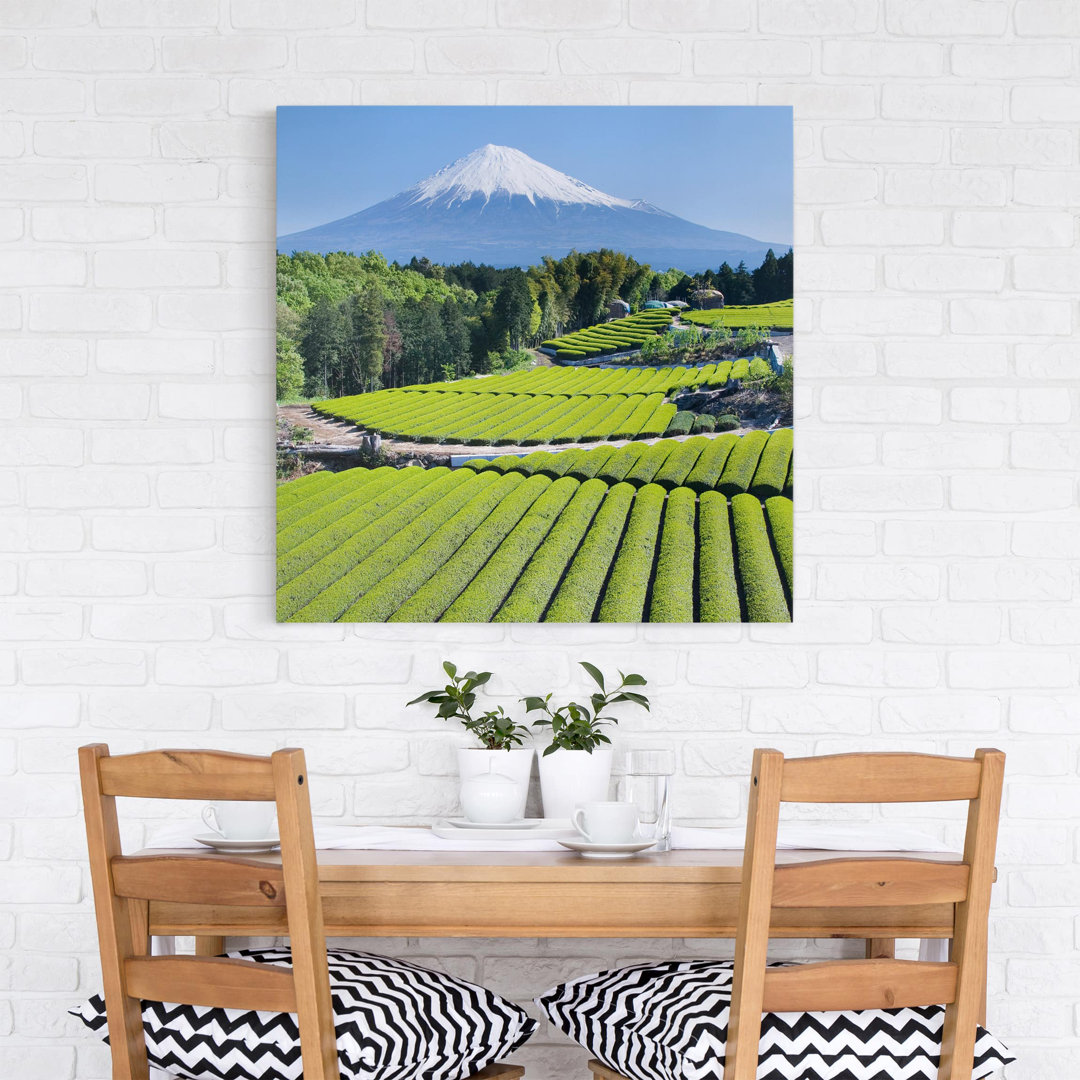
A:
[278,145,789,273]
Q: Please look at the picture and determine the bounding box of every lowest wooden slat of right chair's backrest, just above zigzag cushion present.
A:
[764,960,957,1012]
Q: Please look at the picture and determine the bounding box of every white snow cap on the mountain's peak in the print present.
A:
[408,143,632,207]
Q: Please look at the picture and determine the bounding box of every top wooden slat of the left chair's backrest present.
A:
[98,750,274,802]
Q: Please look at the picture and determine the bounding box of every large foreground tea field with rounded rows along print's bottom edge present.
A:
[278,431,792,622]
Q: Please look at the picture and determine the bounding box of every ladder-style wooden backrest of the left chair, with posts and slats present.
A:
[79,744,339,1080]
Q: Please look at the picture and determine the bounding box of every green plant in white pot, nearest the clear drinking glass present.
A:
[522,660,649,818]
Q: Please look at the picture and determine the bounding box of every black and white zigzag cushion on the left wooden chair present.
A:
[71,948,537,1080]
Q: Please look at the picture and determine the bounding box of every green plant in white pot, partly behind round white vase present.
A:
[409,660,532,818]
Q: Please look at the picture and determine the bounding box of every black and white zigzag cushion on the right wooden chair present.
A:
[536,960,1013,1080]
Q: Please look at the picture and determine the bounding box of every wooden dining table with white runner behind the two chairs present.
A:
[141,849,960,956]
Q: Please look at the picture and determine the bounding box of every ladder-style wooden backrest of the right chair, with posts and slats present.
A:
[724,750,1004,1080]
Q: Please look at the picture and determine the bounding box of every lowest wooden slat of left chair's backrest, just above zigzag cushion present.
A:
[124,956,296,1012]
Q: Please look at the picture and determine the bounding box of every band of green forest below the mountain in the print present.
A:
[278,249,793,401]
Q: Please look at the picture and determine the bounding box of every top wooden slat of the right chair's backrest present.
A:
[780,754,982,802]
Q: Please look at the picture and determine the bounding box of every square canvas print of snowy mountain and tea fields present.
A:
[276,107,794,622]
